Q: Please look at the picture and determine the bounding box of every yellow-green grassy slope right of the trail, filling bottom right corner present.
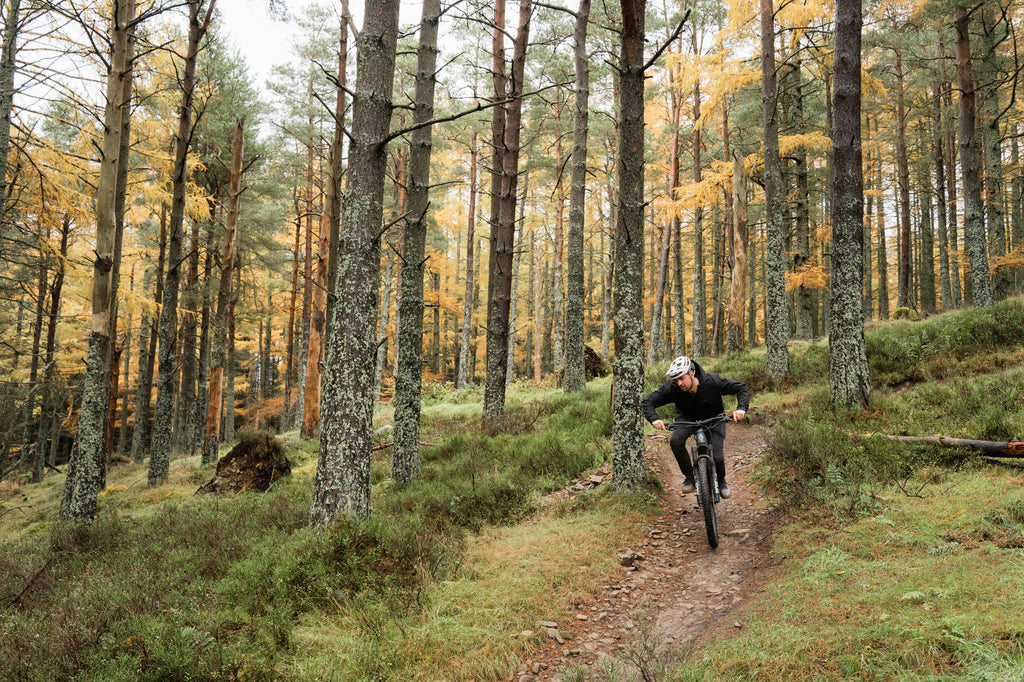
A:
[667,470,1024,681]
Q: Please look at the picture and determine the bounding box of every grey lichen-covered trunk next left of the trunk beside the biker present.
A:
[562,0,590,393]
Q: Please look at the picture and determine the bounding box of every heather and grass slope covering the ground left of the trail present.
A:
[0,389,650,680]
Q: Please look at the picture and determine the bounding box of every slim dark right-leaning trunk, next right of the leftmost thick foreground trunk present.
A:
[148,0,216,485]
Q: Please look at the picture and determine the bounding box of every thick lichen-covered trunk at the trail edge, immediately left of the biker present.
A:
[611,0,646,491]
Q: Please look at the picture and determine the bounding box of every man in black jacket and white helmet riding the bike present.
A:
[641,355,751,498]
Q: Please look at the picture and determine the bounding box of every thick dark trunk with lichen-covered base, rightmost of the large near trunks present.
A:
[828,0,870,408]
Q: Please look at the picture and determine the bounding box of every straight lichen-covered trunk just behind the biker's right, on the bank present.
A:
[761,0,790,379]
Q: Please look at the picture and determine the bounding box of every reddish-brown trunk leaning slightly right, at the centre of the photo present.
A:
[483,0,532,422]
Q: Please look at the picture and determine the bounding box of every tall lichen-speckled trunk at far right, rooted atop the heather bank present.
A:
[955,5,994,306]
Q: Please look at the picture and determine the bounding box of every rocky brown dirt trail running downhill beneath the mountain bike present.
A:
[509,425,777,682]
